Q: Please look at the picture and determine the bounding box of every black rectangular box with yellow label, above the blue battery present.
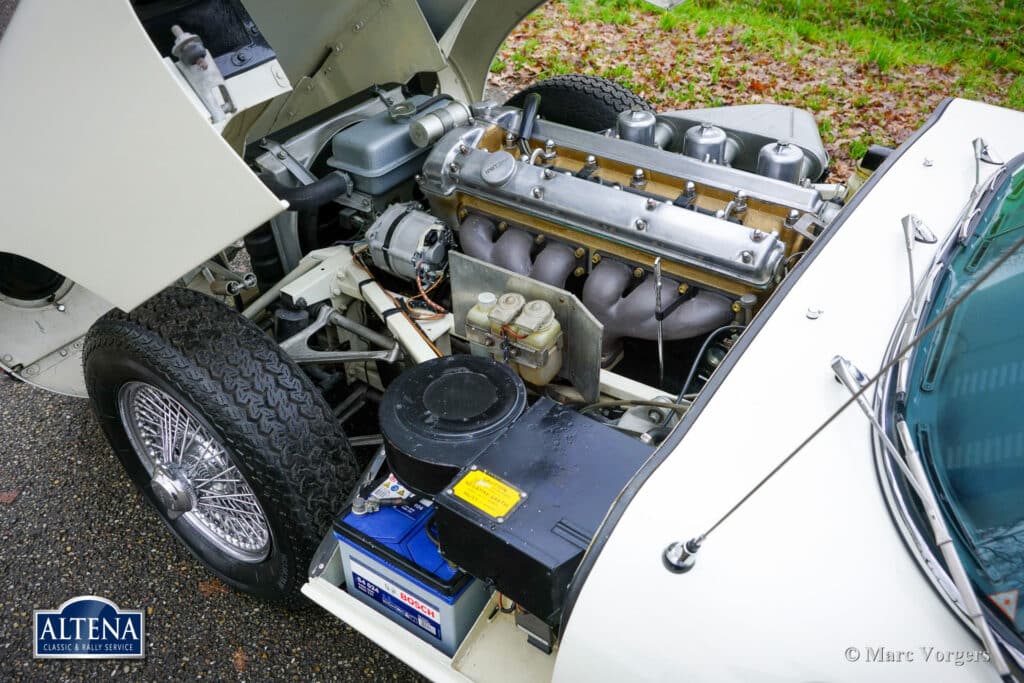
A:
[434,398,652,627]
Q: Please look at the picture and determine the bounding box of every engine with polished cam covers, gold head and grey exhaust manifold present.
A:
[419,108,836,357]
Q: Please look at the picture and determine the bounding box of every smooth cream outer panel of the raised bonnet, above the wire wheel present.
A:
[0,0,283,313]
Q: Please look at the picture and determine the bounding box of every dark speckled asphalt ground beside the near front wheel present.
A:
[0,373,416,681]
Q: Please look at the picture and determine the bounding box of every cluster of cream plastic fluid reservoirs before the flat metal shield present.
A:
[466,292,562,386]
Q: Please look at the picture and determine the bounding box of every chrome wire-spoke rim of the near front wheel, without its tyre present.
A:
[118,382,270,562]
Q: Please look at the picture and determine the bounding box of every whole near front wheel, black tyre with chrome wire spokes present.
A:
[82,287,359,606]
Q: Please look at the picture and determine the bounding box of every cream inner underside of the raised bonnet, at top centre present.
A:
[235,0,542,139]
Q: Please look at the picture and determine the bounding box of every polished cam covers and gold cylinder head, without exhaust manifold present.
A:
[421,110,823,297]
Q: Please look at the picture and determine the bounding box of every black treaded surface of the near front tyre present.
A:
[83,288,358,601]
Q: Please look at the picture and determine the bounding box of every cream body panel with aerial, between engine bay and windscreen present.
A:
[555,100,1024,682]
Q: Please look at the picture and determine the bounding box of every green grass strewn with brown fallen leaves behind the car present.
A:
[492,0,1024,178]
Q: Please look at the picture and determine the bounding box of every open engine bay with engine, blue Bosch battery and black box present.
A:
[245,81,846,654]
